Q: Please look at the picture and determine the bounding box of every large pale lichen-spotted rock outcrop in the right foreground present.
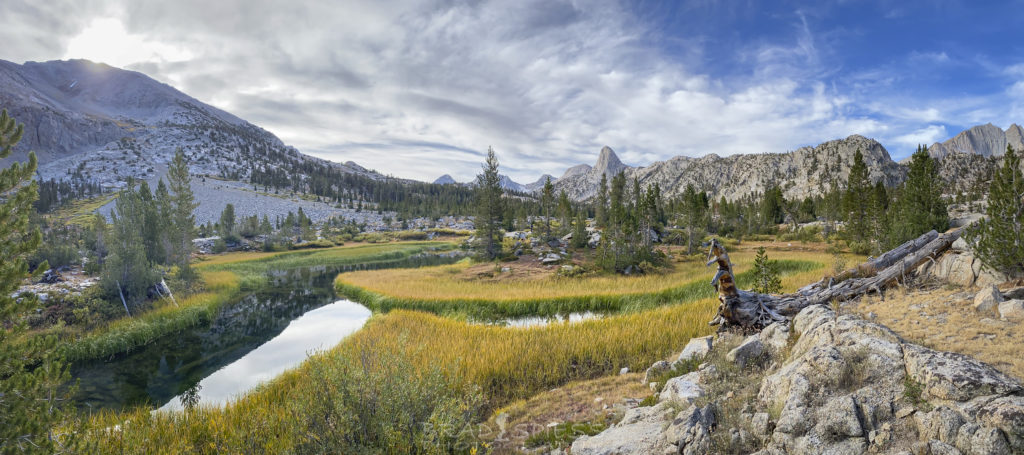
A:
[571,305,1024,455]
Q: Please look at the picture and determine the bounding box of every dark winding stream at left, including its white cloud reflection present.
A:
[71,254,461,411]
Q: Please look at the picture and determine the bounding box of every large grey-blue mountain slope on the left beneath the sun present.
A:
[0,60,383,190]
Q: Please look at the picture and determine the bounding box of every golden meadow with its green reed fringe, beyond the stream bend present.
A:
[335,249,847,320]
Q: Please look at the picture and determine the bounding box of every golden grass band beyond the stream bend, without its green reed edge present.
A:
[337,246,831,301]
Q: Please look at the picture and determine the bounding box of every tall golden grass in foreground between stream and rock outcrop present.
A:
[81,243,839,453]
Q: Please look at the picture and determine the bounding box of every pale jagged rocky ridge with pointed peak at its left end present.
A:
[555,135,906,201]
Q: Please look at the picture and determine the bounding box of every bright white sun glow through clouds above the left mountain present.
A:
[65,17,193,68]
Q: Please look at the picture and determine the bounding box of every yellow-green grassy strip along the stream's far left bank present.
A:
[47,242,451,362]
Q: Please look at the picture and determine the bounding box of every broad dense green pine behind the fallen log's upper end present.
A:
[892,146,949,244]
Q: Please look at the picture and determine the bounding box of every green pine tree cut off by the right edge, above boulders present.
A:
[964,146,1024,277]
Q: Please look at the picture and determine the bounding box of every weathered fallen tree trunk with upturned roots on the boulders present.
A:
[708,230,961,329]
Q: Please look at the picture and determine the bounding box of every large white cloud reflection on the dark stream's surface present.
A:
[160,300,370,410]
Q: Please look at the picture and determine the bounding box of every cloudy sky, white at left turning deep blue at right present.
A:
[0,0,1024,183]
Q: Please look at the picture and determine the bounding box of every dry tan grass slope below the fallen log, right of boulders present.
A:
[853,288,1024,379]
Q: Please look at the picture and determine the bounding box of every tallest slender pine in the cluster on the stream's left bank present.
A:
[167,148,199,278]
